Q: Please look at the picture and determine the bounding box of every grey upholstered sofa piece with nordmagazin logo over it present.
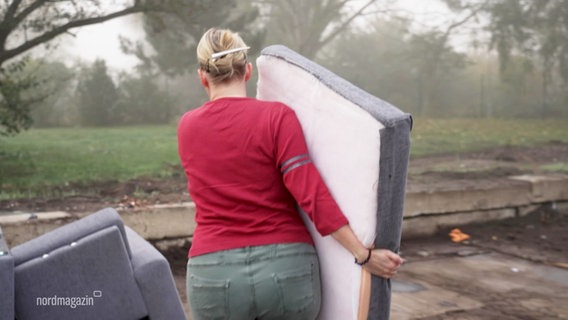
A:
[10,208,185,320]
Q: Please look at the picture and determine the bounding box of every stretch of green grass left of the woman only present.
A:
[0,126,179,198]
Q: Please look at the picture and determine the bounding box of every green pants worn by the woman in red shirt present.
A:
[187,243,321,320]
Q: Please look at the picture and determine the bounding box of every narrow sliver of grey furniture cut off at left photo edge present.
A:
[0,227,14,320]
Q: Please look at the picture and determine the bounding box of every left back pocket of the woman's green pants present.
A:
[187,275,230,320]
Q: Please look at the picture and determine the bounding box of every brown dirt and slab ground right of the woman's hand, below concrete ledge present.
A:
[395,210,568,320]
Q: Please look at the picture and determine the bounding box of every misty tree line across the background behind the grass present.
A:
[0,0,568,135]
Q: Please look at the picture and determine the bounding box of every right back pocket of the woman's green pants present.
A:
[273,265,317,312]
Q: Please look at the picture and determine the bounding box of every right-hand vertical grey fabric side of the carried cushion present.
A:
[368,118,412,320]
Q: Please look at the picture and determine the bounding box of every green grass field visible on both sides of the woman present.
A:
[0,118,568,199]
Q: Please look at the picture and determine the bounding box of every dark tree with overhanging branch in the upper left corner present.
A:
[0,0,160,135]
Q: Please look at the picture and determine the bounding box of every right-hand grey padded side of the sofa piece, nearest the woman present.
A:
[125,227,186,320]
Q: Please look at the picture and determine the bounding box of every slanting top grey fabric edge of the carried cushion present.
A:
[261,45,410,127]
